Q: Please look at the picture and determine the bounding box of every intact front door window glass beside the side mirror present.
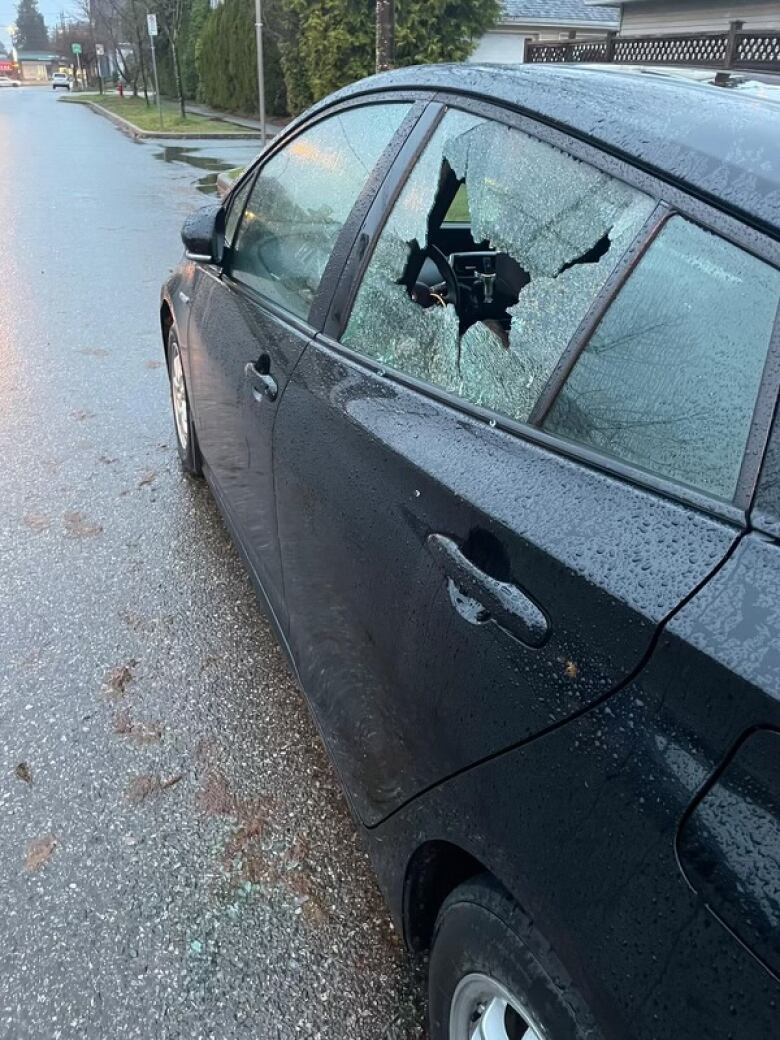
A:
[231,103,411,318]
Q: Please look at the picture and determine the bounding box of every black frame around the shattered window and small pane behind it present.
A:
[320,90,780,526]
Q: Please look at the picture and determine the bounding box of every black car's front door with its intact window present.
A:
[187,101,412,626]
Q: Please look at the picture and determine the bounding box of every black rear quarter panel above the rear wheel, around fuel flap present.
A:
[371,535,780,1040]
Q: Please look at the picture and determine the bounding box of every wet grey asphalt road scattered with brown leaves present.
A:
[0,88,422,1040]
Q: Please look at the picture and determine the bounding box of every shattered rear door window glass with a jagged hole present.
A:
[342,110,655,422]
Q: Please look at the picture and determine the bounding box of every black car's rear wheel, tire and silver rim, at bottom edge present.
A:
[428,875,601,1040]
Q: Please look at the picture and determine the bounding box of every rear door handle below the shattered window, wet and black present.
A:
[425,535,550,647]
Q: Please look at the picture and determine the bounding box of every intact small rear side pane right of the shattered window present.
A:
[544,216,780,499]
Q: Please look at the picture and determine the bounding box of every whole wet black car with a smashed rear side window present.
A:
[161,66,780,1040]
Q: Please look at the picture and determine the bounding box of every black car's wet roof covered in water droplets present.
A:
[315,64,780,235]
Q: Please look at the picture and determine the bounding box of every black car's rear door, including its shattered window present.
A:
[275,101,777,825]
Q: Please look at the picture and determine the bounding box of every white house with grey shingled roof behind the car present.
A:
[469,0,619,62]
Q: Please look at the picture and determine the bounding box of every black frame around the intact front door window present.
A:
[219,90,430,332]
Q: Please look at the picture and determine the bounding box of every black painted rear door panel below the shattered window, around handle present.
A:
[278,336,737,825]
